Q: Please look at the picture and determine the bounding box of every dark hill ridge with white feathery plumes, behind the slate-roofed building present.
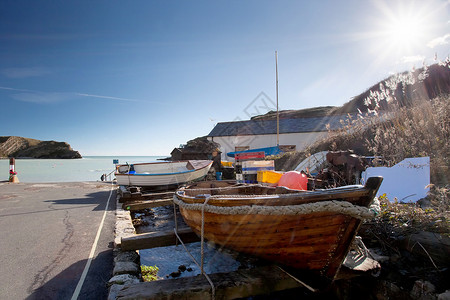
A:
[252,62,450,120]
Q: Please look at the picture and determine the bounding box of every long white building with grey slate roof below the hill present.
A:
[207,115,348,160]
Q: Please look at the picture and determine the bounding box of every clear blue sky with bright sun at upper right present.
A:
[0,0,450,155]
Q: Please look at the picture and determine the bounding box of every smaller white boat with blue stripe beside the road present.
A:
[114,160,212,187]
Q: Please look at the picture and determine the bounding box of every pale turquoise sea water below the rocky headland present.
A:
[0,156,167,183]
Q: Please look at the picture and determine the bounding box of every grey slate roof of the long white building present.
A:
[208,115,348,137]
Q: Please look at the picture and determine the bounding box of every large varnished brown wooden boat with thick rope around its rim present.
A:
[174,177,383,280]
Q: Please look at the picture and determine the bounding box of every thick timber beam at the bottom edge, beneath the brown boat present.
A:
[116,265,308,300]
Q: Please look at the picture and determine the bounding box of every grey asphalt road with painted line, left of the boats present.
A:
[0,182,116,299]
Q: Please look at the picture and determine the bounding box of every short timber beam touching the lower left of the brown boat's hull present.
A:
[120,227,200,251]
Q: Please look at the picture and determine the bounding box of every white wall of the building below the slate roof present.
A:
[208,132,328,160]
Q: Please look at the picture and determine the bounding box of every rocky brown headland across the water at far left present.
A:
[0,136,81,159]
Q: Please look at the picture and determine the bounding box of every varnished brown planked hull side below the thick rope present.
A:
[180,208,359,279]
